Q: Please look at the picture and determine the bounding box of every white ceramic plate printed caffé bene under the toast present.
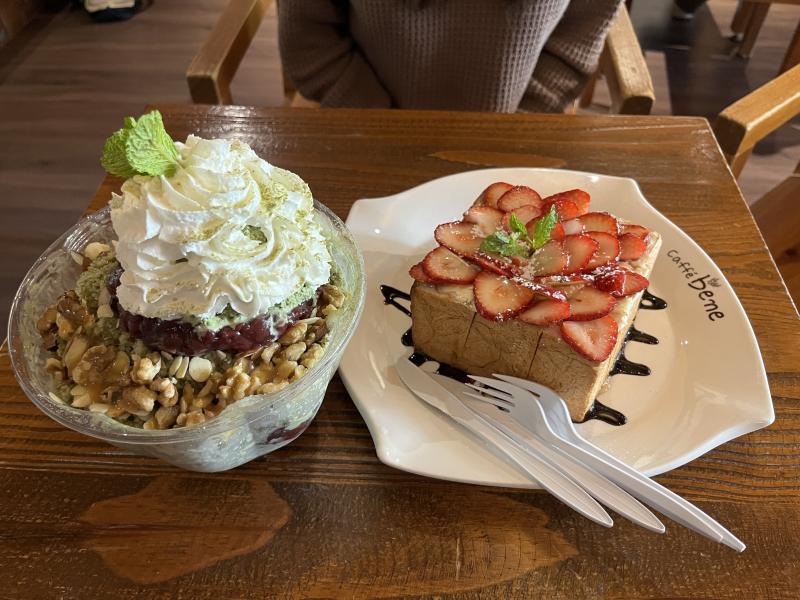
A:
[340,169,775,487]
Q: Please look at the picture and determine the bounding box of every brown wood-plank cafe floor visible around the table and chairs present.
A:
[0,0,800,339]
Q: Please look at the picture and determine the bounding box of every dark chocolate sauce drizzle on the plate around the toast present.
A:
[380,285,667,427]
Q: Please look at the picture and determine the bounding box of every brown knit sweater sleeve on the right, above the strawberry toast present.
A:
[519,0,622,112]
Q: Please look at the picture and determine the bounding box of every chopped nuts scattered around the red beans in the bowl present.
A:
[36,243,346,430]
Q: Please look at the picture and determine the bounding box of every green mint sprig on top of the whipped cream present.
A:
[100,110,178,177]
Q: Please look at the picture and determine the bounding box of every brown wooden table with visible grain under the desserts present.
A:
[0,106,800,600]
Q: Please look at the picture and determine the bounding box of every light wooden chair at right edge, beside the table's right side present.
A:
[714,65,800,301]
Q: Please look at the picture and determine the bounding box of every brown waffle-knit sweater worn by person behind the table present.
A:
[278,0,621,112]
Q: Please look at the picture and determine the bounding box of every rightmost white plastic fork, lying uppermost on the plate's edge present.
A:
[464,375,746,552]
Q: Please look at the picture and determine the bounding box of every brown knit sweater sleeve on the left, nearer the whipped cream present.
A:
[278,0,392,108]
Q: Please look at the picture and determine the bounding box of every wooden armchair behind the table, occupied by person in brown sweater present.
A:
[191,0,655,114]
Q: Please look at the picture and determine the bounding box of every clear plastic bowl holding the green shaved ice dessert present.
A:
[8,202,366,472]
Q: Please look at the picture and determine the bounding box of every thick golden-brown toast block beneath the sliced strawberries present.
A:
[411,232,661,421]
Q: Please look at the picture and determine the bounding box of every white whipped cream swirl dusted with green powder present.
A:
[111,136,331,319]
